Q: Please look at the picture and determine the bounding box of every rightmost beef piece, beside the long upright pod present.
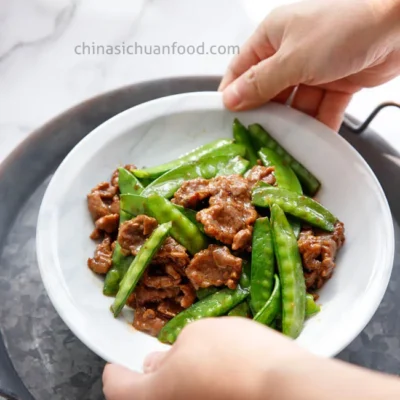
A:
[298,221,345,291]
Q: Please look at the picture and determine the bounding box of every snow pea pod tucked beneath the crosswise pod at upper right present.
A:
[258,147,303,237]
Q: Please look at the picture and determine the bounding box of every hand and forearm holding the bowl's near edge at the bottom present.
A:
[103,317,400,400]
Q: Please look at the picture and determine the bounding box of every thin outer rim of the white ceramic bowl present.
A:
[36,92,395,362]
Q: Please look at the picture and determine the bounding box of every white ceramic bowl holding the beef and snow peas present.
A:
[37,93,394,371]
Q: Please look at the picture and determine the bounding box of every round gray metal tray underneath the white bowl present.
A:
[0,77,400,400]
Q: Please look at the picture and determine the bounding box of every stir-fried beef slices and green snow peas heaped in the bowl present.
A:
[87,120,345,343]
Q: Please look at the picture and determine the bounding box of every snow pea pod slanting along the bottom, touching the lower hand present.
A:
[158,286,249,343]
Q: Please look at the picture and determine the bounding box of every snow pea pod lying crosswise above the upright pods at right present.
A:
[252,184,337,232]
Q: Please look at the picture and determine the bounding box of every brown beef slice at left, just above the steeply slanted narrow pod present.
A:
[117,215,158,255]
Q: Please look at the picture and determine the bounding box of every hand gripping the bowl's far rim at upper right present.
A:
[219,0,400,130]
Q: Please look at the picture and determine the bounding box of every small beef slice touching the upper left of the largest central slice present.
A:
[172,178,213,209]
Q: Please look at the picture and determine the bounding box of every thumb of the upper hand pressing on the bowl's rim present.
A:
[223,51,300,111]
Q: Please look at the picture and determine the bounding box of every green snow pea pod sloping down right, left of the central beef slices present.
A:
[145,195,208,254]
